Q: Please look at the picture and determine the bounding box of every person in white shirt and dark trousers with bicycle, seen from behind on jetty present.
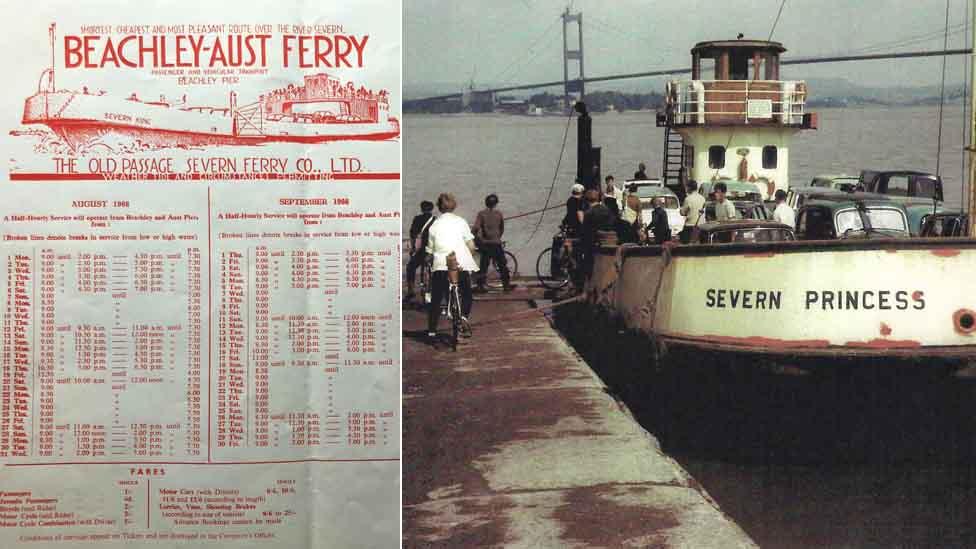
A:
[427,193,478,338]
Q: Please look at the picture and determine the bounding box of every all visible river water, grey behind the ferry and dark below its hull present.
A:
[403,106,976,548]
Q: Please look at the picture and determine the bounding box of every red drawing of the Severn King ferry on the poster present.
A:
[22,27,400,150]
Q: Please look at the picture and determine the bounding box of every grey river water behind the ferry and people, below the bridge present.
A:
[403,106,963,275]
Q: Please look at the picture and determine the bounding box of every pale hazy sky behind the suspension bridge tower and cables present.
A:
[403,0,972,97]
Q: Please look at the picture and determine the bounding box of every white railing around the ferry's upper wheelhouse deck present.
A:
[666,80,807,126]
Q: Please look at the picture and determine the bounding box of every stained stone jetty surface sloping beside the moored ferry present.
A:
[403,294,755,548]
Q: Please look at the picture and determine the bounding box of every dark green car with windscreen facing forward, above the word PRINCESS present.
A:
[796,193,911,240]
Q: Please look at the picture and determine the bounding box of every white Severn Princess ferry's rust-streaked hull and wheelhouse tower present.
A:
[585,40,976,368]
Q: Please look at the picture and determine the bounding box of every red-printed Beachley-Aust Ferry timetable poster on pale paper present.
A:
[0,0,401,549]
